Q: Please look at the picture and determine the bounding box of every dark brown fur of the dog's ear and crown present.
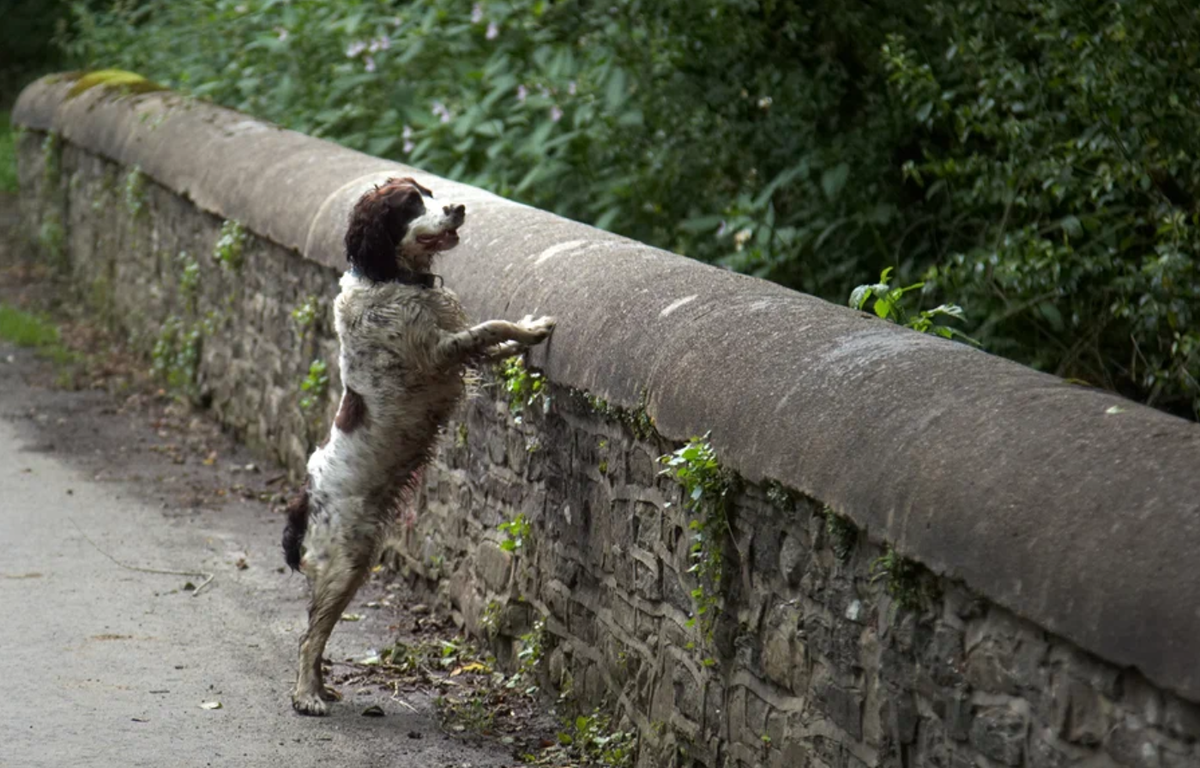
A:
[346,179,425,282]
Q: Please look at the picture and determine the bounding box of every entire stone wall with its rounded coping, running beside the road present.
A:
[14,76,1200,768]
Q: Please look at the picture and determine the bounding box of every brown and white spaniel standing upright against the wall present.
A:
[283,178,554,715]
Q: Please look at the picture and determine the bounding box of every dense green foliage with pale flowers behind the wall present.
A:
[68,0,1200,414]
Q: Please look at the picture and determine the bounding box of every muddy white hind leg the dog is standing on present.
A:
[292,552,371,715]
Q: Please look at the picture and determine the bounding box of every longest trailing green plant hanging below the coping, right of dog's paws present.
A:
[659,434,732,640]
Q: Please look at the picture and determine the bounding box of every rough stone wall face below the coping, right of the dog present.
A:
[408,386,1200,768]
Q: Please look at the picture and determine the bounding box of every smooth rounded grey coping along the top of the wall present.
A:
[13,77,1200,701]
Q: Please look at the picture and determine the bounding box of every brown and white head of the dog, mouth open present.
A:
[346,178,467,282]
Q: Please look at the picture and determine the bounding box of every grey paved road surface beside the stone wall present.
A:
[0,344,515,768]
